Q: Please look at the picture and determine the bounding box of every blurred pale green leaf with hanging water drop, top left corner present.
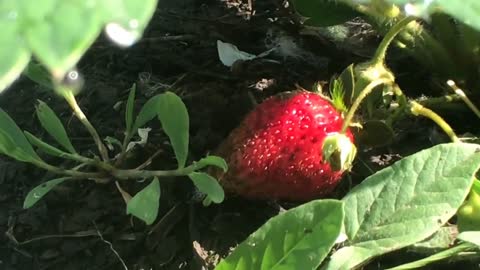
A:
[0,0,157,90]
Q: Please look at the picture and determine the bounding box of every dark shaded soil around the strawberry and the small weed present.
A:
[0,0,478,270]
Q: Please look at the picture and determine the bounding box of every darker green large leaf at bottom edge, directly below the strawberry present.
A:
[215,200,344,270]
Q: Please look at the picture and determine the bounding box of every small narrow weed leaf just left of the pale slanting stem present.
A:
[36,100,77,153]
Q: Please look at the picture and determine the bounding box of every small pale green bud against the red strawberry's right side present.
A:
[322,133,357,172]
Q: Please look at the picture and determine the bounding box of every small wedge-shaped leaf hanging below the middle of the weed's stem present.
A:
[127,177,160,225]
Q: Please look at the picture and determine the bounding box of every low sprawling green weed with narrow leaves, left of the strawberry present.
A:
[0,87,224,224]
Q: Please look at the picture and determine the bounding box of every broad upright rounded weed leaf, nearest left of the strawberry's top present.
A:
[157,92,189,168]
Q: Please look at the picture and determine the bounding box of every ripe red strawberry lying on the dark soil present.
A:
[217,91,356,201]
